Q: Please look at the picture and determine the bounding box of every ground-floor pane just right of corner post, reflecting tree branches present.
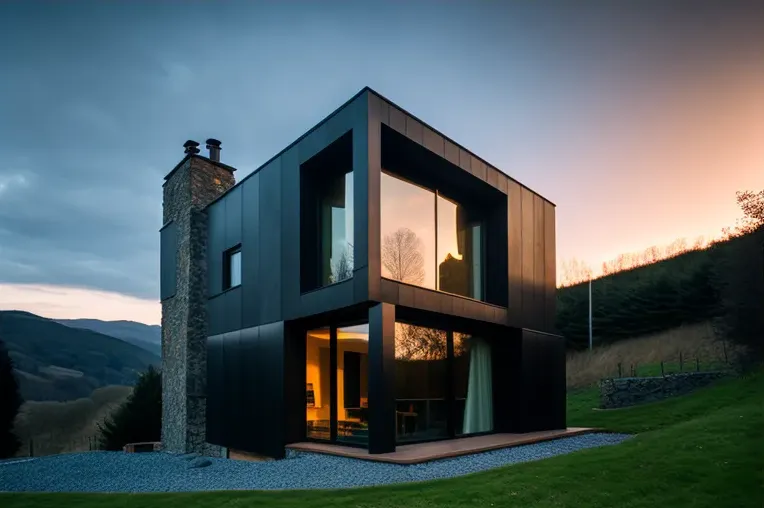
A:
[395,323,448,443]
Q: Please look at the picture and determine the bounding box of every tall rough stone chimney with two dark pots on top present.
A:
[162,140,235,455]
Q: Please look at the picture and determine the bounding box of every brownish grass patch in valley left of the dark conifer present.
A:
[15,386,132,456]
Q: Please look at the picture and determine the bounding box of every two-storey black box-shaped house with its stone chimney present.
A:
[161,88,566,458]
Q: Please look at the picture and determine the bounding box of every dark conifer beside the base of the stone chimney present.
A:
[98,366,162,451]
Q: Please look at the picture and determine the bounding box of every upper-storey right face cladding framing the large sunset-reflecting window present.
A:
[368,92,556,331]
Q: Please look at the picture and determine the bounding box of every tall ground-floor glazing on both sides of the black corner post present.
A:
[305,322,493,446]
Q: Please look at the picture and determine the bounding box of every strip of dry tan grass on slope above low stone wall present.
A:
[567,322,734,389]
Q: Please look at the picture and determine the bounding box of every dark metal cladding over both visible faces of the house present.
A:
[178,88,565,457]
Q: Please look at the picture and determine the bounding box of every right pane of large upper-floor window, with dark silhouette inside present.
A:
[438,196,483,300]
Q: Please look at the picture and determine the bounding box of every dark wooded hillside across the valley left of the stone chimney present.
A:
[0,311,160,401]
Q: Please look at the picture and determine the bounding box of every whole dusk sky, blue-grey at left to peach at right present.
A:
[0,0,764,324]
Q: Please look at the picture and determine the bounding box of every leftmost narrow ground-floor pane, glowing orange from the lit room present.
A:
[305,328,331,440]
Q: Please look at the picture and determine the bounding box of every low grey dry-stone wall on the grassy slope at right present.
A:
[600,372,727,409]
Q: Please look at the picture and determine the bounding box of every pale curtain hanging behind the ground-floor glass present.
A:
[462,337,493,434]
